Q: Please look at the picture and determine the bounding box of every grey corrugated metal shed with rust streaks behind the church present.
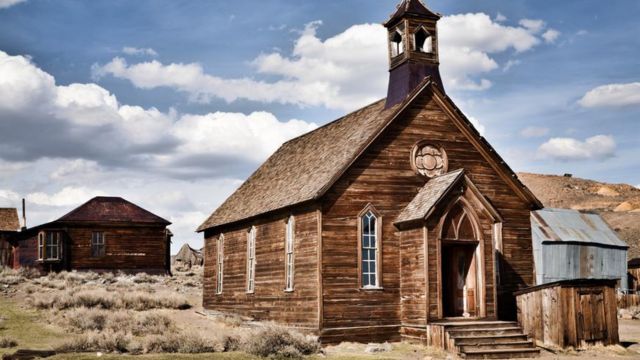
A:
[531,209,629,289]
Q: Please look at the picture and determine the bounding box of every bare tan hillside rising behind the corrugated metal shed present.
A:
[518,173,640,259]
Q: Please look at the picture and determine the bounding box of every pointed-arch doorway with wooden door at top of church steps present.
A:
[440,201,481,317]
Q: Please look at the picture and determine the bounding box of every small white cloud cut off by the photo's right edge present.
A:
[578,82,640,108]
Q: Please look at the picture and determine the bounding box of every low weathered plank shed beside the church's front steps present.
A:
[517,281,619,349]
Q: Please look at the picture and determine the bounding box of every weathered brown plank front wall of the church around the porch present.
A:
[322,90,533,340]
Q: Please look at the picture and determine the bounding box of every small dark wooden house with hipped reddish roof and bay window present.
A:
[13,197,171,274]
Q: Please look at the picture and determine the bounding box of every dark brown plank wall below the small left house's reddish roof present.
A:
[67,225,168,274]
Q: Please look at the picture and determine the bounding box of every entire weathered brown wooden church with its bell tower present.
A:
[198,0,542,351]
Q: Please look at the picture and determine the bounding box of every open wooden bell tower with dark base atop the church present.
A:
[384,0,444,108]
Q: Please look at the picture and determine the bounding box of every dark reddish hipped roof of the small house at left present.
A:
[57,196,171,225]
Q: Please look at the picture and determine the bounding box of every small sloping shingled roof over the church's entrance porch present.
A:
[394,169,464,224]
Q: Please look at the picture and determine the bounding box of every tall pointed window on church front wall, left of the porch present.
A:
[359,207,382,289]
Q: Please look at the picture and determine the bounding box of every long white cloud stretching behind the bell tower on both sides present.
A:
[93,13,556,110]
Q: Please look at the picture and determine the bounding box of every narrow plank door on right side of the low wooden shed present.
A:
[578,290,607,343]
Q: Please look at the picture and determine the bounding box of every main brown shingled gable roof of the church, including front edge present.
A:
[197,78,542,232]
